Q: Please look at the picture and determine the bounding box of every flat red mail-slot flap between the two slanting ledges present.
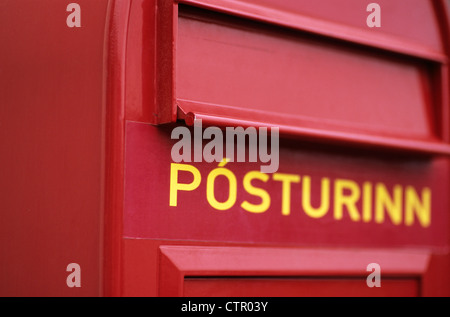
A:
[176,8,438,140]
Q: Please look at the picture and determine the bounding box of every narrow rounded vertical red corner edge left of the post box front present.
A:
[102,0,130,296]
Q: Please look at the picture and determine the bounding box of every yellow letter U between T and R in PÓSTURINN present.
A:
[302,176,330,218]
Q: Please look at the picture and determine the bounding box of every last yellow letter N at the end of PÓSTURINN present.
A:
[405,186,431,227]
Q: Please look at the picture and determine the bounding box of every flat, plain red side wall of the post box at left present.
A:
[0,0,107,296]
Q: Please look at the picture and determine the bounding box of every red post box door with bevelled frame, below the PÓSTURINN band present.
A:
[159,246,430,297]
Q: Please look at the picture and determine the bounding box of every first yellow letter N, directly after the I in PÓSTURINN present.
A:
[375,183,403,225]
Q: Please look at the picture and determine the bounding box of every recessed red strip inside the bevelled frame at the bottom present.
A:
[184,277,420,296]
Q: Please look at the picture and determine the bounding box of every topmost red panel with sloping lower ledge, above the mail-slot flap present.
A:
[180,0,445,60]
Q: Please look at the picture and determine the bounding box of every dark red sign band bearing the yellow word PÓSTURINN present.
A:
[124,122,448,246]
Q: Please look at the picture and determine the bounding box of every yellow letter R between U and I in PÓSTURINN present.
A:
[334,179,361,221]
